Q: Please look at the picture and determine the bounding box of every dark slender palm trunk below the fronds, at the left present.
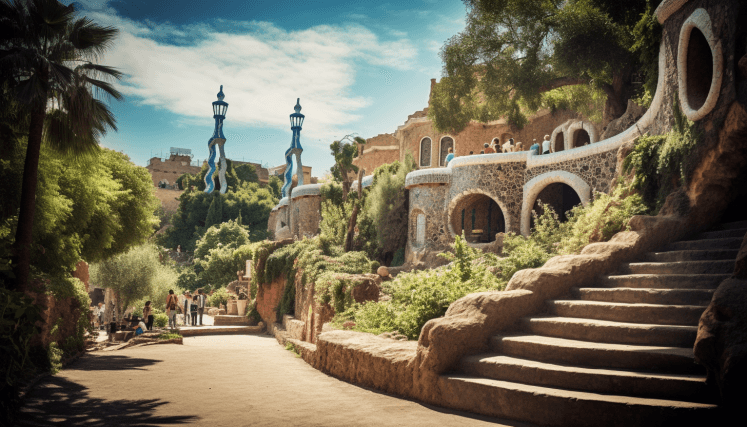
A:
[13,101,47,291]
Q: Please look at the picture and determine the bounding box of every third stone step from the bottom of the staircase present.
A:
[490,335,705,375]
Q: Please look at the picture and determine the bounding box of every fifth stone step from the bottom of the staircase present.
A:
[547,300,707,326]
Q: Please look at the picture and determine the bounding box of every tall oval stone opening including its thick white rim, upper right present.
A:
[677,8,724,121]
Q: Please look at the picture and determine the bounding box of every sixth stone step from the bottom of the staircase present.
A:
[571,288,715,306]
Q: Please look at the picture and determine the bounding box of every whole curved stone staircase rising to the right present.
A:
[439,221,747,426]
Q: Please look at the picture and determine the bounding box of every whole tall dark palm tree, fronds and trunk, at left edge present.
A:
[0,0,122,290]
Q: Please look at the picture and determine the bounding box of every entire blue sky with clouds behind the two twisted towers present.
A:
[63,0,466,176]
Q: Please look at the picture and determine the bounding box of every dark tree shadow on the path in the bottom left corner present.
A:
[18,377,199,426]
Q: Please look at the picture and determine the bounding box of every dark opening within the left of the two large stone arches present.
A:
[451,193,506,243]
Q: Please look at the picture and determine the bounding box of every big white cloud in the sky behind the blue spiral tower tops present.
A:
[87,10,417,142]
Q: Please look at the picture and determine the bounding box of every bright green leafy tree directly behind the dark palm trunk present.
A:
[0,142,160,276]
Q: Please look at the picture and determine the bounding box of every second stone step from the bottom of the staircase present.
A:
[459,354,713,403]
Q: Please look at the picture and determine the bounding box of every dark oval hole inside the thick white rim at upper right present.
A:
[686,27,713,110]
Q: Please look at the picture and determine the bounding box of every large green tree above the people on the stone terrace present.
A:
[429,0,658,131]
